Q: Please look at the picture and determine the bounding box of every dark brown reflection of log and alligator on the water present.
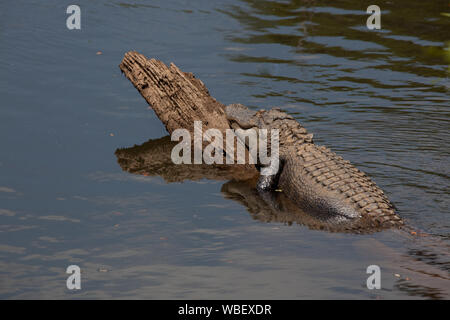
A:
[115,136,390,233]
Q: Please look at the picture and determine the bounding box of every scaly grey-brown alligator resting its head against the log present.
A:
[225,104,404,228]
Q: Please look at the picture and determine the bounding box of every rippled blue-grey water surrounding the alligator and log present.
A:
[0,0,450,299]
